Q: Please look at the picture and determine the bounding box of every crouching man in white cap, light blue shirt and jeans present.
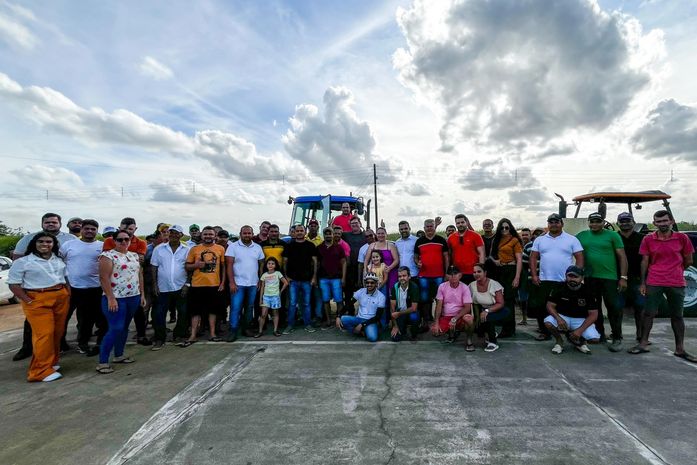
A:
[338,273,387,342]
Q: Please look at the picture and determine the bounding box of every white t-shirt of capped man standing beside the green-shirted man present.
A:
[532,231,583,282]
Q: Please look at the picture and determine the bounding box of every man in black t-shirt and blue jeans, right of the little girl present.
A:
[283,225,317,334]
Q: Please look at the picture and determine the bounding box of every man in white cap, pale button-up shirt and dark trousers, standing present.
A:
[150,224,189,350]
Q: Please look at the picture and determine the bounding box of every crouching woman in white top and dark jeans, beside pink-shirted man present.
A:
[470,263,510,352]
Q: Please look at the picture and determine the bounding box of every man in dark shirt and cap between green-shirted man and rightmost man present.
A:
[617,212,646,343]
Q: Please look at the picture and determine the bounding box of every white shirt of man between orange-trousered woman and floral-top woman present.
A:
[60,239,104,289]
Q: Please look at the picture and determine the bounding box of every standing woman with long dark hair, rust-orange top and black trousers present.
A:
[490,218,523,338]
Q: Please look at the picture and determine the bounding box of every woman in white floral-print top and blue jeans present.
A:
[97,231,145,374]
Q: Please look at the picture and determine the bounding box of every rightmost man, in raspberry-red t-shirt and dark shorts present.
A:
[629,210,697,363]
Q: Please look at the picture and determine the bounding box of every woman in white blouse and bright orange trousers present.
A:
[7,232,70,382]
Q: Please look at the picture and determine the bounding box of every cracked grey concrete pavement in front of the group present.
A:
[0,320,697,465]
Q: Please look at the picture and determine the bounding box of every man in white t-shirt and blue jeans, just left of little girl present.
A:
[225,226,264,342]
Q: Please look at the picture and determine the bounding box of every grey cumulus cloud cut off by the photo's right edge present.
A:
[631,99,697,163]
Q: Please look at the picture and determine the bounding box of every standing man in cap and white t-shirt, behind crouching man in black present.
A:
[528,213,583,341]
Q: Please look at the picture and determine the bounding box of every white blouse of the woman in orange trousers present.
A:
[7,253,66,289]
